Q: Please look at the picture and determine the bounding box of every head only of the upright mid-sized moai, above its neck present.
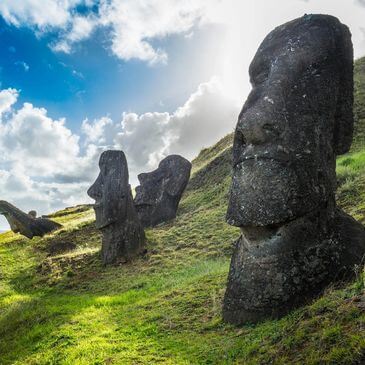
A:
[87,151,131,229]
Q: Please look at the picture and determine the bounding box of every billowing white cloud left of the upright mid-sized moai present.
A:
[0,89,102,228]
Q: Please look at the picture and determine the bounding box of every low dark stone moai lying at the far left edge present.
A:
[0,200,62,238]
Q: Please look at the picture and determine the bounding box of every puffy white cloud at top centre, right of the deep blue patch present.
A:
[100,0,216,64]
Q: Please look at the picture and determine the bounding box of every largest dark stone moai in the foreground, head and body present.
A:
[223,15,365,324]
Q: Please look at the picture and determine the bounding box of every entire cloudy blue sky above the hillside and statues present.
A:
[0,0,365,230]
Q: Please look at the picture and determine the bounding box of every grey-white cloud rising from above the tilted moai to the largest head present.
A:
[114,78,240,170]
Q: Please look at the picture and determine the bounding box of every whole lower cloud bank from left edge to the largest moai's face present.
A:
[0,79,239,228]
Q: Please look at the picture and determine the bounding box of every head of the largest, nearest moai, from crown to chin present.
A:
[227,15,353,227]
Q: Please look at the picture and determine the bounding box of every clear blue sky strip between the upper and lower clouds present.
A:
[0,18,225,131]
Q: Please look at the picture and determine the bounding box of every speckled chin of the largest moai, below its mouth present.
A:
[226,159,326,227]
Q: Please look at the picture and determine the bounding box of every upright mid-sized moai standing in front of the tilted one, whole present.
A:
[87,151,145,264]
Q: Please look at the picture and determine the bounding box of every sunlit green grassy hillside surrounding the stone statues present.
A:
[0,61,365,365]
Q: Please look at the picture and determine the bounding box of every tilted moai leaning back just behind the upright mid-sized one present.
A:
[134,155,191,227]
